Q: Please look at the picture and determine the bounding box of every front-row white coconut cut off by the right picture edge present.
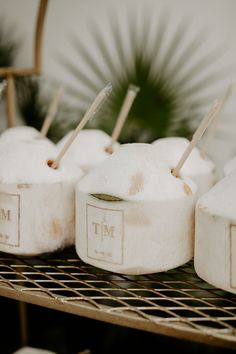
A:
[194,171,236,294]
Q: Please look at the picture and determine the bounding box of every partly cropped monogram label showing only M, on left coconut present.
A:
[0,193,20,247]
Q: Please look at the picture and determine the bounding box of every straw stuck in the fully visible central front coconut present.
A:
[172,102,221,177]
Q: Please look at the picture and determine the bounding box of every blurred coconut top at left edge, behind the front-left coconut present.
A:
[0,125,54,148]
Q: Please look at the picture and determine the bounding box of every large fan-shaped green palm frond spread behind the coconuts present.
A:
[58,11,225,142]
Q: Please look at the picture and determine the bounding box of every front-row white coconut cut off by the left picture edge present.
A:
[0,140,83,255]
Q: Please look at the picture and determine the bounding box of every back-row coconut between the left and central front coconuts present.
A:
[57,129,119,172]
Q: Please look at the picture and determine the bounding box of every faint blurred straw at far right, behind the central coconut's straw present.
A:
[200,82,235,158]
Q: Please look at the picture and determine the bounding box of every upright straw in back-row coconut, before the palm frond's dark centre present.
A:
[106,84,140,154]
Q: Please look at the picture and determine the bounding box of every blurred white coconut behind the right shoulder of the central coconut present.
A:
[153,137,215,197]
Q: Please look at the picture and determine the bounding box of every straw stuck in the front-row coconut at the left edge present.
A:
[50,84,112,169]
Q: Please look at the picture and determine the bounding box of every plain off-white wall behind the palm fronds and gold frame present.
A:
[0,0,236,171]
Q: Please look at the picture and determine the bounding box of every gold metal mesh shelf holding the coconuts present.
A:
[0,249,236,348]
